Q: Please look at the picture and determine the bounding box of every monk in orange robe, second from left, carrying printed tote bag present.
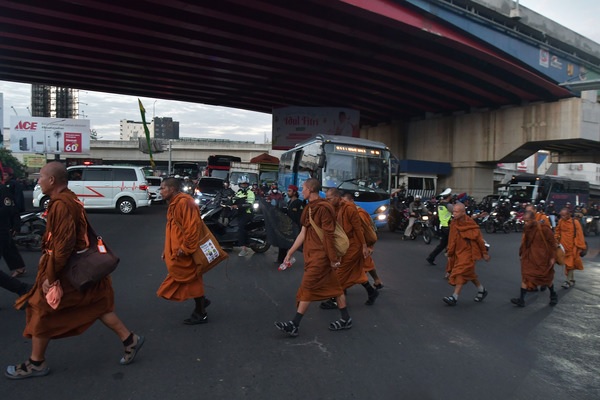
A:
[156,178,210,325]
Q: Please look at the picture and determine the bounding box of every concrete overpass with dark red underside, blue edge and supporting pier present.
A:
[0,0,600,195]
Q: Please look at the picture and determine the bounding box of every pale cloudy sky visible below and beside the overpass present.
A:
[0,0,600,143]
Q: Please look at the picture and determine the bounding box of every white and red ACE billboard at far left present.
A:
[10,116,90,156]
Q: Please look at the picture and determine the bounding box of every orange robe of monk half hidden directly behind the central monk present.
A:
[336,202,368,290]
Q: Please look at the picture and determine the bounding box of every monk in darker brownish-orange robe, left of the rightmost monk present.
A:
[510,210,558,307]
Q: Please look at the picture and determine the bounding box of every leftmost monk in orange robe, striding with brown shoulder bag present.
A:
[5,162,144,379]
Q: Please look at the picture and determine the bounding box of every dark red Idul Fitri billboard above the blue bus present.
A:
[272,107,360,150]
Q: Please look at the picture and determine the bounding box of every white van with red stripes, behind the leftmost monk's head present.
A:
[33,165,151,214]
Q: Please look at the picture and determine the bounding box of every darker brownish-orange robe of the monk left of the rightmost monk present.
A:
[519,222,556,289]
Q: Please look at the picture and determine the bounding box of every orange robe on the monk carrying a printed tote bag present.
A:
[156,193,204,301]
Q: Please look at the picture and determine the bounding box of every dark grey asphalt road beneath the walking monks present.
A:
[0,206,600,400]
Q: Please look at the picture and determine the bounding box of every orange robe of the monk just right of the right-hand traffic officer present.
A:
[446,217,487,286]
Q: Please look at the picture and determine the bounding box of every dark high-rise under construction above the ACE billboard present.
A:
[31,84,79,118]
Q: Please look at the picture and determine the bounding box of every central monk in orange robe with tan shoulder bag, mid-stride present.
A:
[275,178,352,337]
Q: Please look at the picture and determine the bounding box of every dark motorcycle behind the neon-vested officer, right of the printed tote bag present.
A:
[202,205,271,253]
